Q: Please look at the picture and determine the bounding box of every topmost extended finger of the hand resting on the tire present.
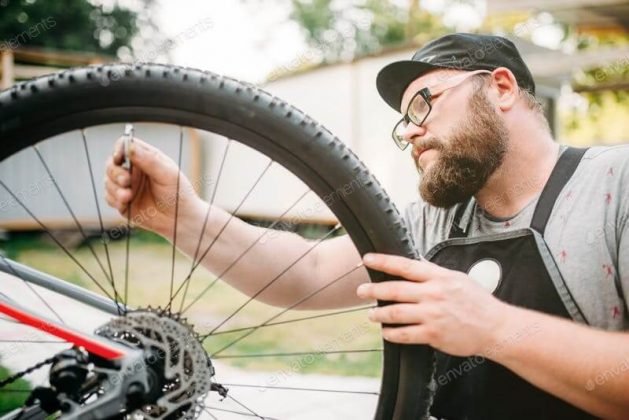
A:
[363,253,449,281]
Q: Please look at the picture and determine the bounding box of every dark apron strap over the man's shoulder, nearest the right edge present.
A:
[531,147,587,237]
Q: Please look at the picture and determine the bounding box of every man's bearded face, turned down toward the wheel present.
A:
[402,70,508,208]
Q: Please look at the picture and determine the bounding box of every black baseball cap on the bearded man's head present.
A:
[376,33,535,112]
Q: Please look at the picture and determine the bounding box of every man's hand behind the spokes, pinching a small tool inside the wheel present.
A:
[105,138,201,236]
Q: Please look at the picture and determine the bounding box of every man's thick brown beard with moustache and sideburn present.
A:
[416,89,509,208]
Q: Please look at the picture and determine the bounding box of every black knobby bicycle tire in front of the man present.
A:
[0,64,434,420]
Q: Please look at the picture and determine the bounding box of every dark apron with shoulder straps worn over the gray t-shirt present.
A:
[426,148,595,420]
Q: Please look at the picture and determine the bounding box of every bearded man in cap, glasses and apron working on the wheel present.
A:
[106,33,629,420]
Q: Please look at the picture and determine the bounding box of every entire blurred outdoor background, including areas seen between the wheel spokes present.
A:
[0,0,629,419]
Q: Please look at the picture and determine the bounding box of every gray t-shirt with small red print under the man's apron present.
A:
[404,144,629,331]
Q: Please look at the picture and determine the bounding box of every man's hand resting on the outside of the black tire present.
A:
[357,254,512,356]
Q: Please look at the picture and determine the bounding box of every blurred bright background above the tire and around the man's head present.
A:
[0,0,629,207]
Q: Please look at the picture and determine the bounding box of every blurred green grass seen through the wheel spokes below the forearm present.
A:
[5,232,382,376]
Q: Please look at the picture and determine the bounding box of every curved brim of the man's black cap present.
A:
[376,60,443,112]
